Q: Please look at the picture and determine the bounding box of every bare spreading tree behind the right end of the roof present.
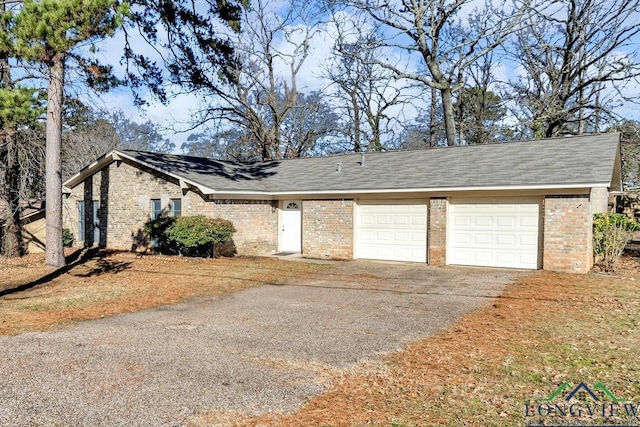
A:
[512,0,640,137]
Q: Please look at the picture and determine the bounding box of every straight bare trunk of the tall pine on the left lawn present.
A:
[45,54,65,267]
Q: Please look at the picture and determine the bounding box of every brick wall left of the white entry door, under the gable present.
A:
[63,162,278,254]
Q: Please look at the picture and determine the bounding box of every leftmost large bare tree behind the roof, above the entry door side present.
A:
[158,0,332,160]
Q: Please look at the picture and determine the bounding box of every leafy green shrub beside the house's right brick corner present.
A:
[593,213,640,271]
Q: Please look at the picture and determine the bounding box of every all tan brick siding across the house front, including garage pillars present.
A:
[63,161,607,273]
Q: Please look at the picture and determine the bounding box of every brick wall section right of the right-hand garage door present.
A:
[543,195,593,273]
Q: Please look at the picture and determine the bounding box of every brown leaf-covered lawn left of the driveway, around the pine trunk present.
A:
[0,251,322,335]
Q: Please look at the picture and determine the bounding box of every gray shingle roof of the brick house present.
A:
[115,133,619,193]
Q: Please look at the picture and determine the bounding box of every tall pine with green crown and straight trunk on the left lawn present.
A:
[0,0,129,267]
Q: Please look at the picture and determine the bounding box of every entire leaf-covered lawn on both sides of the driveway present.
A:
[0,249,640,426]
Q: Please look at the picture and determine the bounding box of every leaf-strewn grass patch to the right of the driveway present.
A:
[230,272,640,426]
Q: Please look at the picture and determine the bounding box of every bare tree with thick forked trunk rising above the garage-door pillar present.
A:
[340,0,527,145]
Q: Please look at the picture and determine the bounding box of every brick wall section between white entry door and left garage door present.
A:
[302,200,354,259]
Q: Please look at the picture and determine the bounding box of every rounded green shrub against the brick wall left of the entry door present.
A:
[145,215,236,256]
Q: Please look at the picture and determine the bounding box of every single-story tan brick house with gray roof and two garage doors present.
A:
[64,133,622,273]
